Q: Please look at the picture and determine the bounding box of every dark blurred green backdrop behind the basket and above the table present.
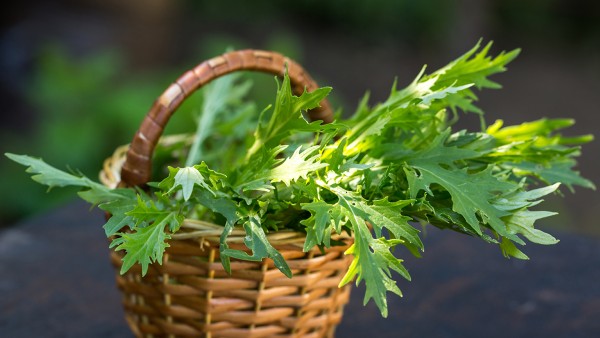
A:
[0,0,600,235]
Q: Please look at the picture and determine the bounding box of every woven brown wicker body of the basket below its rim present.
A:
[111,230,350,337]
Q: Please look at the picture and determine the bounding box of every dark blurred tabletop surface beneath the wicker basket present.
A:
[0,203,600,338]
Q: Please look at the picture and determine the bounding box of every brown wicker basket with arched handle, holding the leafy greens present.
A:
[101,50,352,337]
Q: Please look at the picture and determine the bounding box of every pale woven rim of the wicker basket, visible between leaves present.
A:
[99,139,352,247]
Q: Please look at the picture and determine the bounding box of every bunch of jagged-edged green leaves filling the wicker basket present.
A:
[7,44,594,316]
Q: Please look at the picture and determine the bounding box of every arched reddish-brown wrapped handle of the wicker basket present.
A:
[119,50,333,187]
